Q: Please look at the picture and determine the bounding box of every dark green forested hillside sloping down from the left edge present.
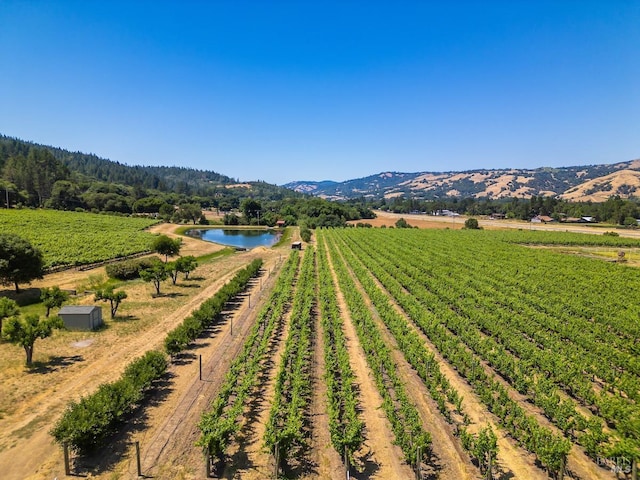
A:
[0,136,371,227]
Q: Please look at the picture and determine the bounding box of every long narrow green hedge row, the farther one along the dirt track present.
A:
[164,258,262,355]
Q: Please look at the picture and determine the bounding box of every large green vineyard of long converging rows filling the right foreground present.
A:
[189,229,640,479]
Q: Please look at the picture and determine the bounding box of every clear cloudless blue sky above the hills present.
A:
[0,0,640,184]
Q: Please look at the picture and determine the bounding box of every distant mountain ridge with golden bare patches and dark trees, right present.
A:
[283,159,640,202]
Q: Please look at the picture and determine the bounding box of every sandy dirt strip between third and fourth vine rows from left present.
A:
[322,242,415,480]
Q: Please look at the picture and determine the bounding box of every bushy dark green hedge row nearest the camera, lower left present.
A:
[51,350,167,453]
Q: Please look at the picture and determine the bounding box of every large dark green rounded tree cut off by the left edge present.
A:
[0,233,44,293]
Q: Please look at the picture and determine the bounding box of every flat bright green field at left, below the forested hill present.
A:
[0,209,158,268]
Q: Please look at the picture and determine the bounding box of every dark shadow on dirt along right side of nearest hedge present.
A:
[67,372,175,477]
